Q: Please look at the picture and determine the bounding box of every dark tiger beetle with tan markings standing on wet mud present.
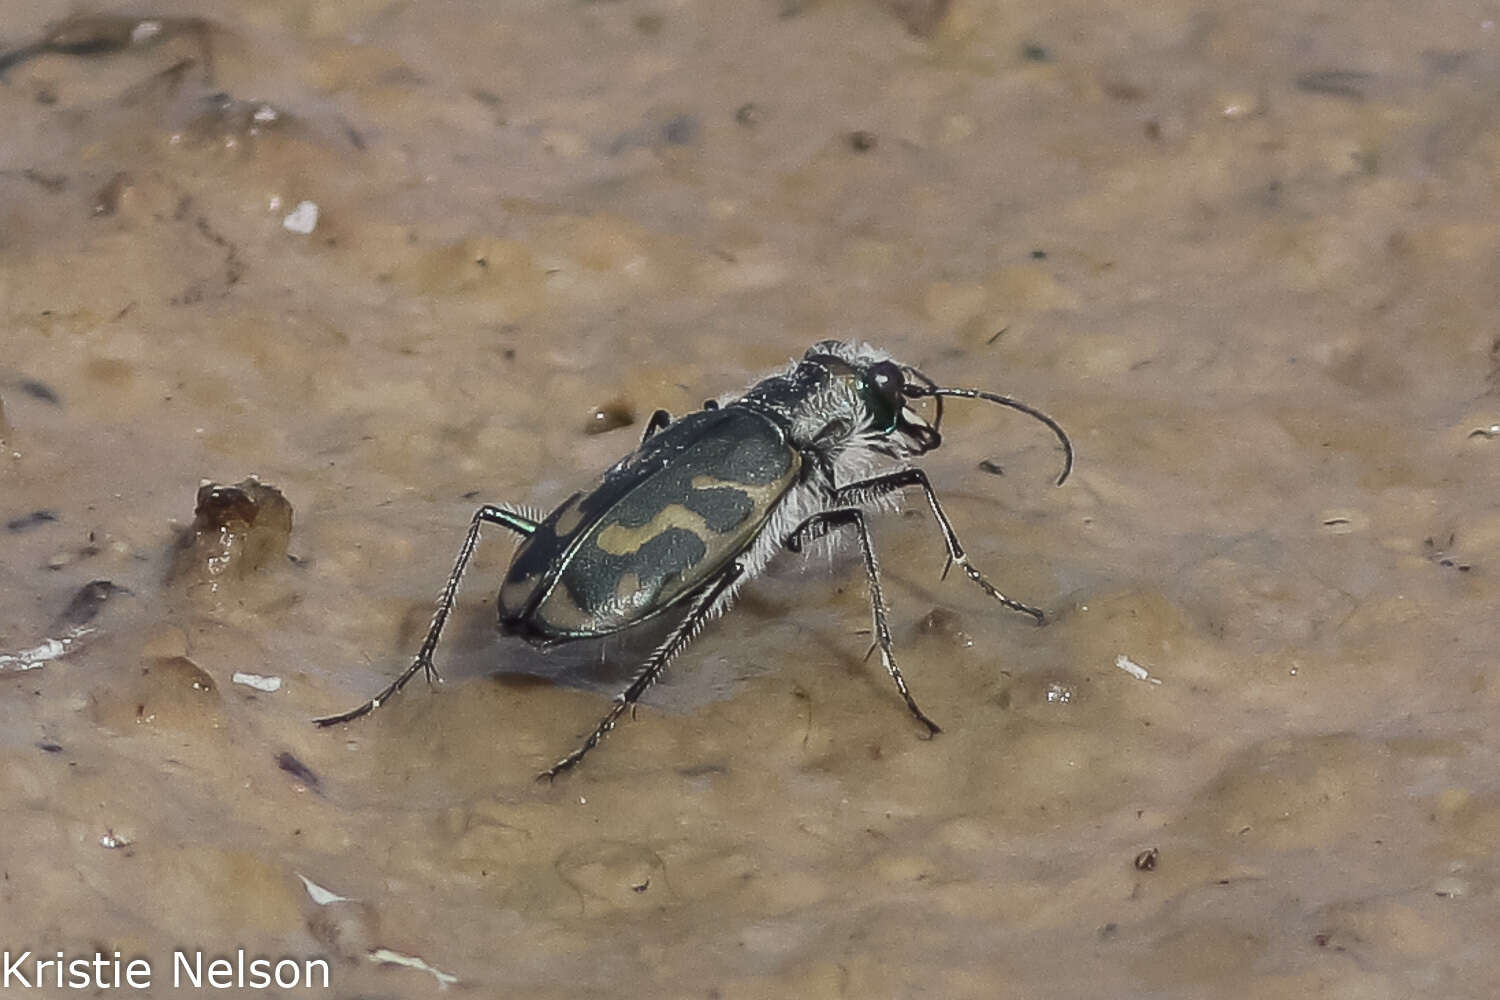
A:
[315,340,1073,780]
